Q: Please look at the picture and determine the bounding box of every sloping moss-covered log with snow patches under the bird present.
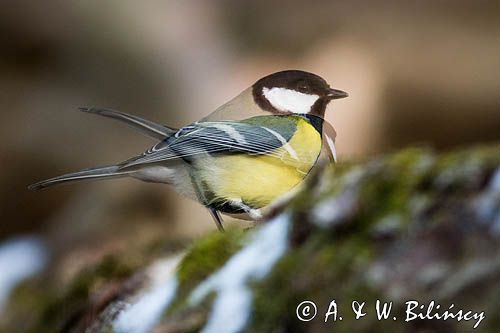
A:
[1,145,500,332]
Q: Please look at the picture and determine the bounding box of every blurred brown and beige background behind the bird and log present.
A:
[0,0,500,248]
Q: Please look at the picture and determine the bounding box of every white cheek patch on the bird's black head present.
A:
[262,87,319,113]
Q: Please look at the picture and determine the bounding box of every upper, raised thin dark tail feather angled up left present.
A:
[79,107,177,140]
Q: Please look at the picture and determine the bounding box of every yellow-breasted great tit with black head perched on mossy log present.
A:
[29,70,348,231]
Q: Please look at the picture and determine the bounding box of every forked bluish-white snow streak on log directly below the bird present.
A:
[189,214,290,333]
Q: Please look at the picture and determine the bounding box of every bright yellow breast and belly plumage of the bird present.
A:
[197,119,321,208]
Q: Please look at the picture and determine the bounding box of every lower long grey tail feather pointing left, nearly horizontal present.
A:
[28,165,131,190]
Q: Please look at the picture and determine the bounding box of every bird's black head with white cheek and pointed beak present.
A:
[252,70,348,117]
